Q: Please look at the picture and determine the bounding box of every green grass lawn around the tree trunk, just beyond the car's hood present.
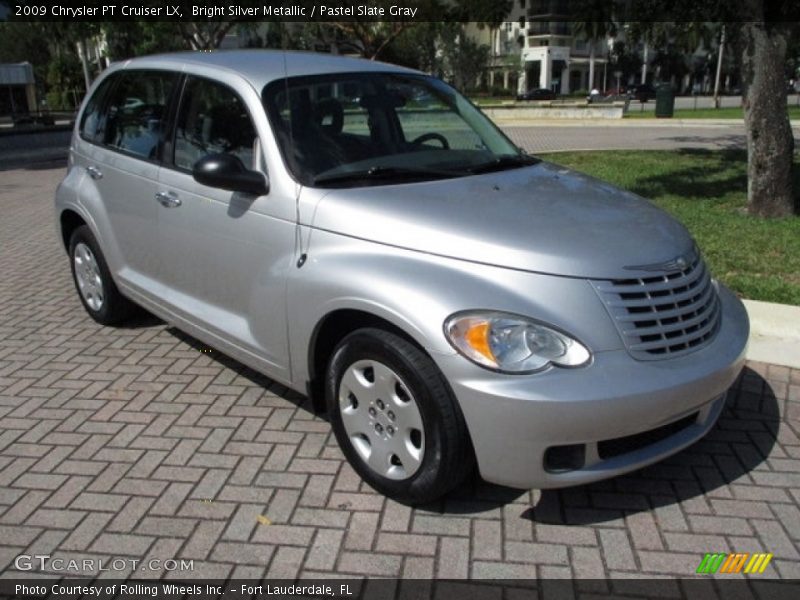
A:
[545,150,800,305]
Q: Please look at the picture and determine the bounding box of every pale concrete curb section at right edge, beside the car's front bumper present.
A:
[742,300,800,369]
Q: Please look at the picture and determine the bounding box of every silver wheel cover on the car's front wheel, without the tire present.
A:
[338,360,425,480]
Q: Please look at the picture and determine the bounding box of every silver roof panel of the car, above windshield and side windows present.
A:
[119,50,419,90]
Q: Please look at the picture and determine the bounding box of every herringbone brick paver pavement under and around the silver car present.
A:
[0,169,800,584]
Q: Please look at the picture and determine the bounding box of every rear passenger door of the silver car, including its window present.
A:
[73,70,179,296]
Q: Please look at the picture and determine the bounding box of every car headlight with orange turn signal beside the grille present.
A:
[444,311,591,373]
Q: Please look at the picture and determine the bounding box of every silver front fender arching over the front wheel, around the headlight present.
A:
[287,230,622,383]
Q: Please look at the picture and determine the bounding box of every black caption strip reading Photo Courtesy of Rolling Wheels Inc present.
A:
[0,574,800,600]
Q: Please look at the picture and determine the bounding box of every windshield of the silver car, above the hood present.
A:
[263,72,535,187]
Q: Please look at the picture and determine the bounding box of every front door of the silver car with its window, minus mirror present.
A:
[157,75,295,378]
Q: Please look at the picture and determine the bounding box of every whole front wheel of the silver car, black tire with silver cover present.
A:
[325,328,474,504]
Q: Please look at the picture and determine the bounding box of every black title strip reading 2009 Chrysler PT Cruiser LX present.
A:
[0,0,800,25]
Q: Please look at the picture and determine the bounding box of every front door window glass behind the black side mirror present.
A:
[175,77,256,170]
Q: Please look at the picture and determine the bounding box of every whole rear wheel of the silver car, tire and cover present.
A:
[69,225,137,325]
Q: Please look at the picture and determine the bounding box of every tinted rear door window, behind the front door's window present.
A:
[99,71,178,160]
